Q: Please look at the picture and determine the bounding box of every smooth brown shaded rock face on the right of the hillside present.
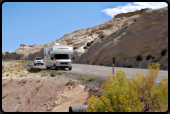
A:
[72,8,168,70]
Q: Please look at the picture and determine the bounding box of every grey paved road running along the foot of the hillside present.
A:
[23,60,168,84]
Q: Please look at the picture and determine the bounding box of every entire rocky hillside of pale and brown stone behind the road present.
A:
[3,7,168,70]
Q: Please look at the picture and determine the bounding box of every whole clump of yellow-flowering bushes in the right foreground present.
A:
[86,63,168,112]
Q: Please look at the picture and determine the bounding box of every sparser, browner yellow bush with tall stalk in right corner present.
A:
[131,63,168,112]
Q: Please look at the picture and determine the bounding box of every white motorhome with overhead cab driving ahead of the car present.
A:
[44,43,74,70]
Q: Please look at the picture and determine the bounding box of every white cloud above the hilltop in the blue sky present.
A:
[101,2,168,18]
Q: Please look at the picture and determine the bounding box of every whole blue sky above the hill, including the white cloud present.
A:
[2,2,167,53]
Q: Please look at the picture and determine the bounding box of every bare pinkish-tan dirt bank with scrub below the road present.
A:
[2,61,105,112]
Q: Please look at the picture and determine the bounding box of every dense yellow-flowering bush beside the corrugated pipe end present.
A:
[87,70,142,112]
